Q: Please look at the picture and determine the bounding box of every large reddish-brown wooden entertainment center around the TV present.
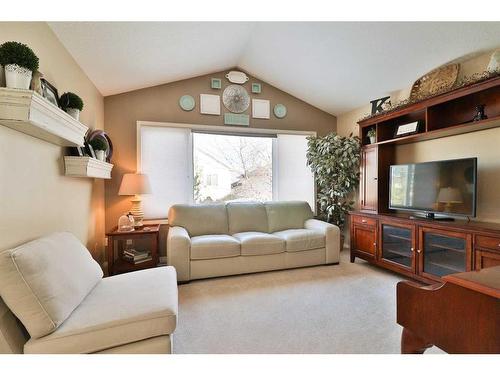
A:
[350,77,500,282]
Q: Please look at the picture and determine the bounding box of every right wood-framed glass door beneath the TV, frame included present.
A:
[417,227,472,280]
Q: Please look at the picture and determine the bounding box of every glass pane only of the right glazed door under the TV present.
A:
[420,231,468,277]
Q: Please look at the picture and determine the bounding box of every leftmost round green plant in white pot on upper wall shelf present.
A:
[0,42,38,90]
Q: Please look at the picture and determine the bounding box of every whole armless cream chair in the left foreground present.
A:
[0,233,177,354]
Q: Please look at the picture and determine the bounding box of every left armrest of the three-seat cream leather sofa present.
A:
[167,227,191,281]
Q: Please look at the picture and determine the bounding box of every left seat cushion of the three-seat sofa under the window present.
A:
[191,234,240,259]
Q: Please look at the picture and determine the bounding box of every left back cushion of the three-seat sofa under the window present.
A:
[168,204,228,237]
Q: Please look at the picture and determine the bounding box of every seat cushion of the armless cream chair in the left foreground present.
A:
[24,267,177,353]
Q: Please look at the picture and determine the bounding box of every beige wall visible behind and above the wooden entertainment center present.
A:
[337,51,500,228]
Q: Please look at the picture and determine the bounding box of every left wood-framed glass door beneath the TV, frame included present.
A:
[379,221,416,273]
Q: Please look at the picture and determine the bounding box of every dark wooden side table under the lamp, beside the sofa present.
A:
[106,224,160,276]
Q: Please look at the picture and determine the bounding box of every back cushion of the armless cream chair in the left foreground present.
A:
[0,232,103,338]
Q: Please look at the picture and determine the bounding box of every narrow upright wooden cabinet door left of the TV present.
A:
[360,147,378,211]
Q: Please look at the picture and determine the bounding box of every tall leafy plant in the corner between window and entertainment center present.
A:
[307,133,361,229]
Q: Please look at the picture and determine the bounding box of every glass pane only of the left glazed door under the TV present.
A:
[381,224,413,269]
